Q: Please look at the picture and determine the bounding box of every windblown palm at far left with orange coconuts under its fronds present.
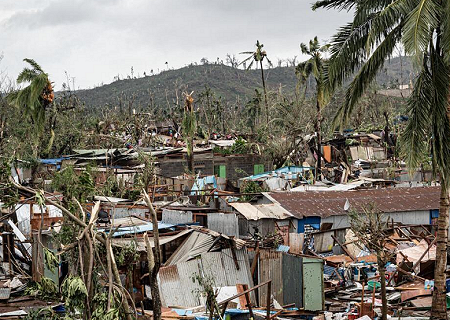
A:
[8,59,55,157]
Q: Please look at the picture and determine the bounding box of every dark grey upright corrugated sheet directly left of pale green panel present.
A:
[280,254,303,308]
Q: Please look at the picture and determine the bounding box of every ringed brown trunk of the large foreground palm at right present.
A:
[431,183,450,320]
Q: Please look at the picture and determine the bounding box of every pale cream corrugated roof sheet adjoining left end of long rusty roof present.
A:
[230,202,292,220]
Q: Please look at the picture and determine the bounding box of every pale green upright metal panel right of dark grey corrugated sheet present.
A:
[303,258,324,311]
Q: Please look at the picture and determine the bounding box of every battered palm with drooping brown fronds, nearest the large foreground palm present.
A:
[295,37,330,180]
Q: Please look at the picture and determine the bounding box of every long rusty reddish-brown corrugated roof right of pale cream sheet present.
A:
[267,187,440,219]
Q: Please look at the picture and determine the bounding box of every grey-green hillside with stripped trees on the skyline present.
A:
[77,58,412,107]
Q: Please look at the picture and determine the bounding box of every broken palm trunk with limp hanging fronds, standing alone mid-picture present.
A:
[182,92,197,174]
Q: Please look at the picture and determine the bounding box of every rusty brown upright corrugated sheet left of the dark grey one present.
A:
[259,250,283,307]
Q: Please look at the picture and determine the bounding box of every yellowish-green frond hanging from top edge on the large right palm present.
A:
[403,0,440,61]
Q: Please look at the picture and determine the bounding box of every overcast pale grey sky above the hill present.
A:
[0,0,350,89]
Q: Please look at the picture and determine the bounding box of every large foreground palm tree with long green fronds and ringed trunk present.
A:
[313,0,450,319]
